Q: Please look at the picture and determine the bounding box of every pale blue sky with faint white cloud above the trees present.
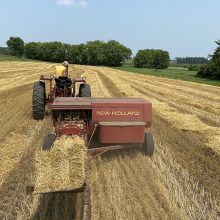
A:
[0,0,220,58]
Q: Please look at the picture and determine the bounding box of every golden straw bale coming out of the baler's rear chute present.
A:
[35,136,86,192]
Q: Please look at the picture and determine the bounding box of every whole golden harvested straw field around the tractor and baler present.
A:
[0,62,220,219]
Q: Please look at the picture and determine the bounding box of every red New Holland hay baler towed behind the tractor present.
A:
[43,97,154,156]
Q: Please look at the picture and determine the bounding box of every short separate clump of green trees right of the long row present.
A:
[134,49,170,69]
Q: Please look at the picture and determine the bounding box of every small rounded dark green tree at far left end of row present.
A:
[6,37,24,57]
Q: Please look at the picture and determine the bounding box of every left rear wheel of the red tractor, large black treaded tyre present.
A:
[32,81,46,120]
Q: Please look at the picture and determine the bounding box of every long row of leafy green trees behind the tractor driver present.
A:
[7,37,132,66]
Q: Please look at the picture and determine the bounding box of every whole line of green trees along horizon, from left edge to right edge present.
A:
[4,37,220,79]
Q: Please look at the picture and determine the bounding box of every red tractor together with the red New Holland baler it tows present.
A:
[33,76,154,156]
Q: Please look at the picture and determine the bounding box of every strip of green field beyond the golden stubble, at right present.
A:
[114,65,220,86]
